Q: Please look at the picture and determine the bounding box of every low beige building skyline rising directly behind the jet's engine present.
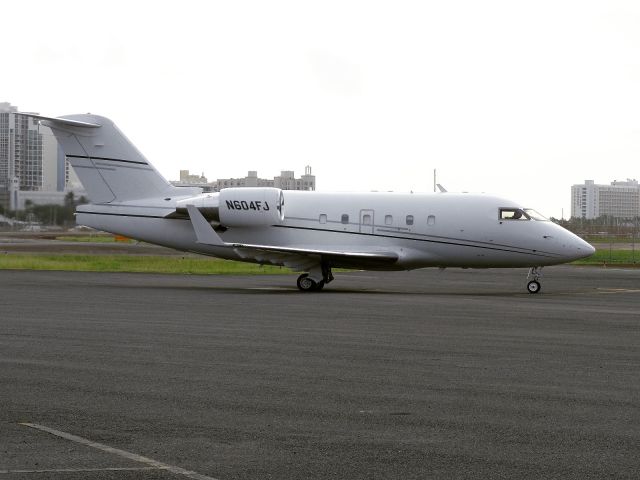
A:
[171,166,316,191]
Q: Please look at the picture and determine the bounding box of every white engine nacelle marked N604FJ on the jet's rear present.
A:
[218,187,284,227]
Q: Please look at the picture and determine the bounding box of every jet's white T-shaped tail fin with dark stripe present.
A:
[19,114,185,203]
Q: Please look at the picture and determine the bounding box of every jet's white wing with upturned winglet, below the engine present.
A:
[187,205,399,270]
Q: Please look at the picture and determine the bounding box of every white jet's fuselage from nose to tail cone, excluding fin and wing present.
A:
[77,192,593,270]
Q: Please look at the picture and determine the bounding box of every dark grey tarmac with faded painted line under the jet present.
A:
[0,267,640,480]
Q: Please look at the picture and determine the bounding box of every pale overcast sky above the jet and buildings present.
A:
[5,0,640,217]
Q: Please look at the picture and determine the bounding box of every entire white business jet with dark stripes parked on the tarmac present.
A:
[20,114,595,293]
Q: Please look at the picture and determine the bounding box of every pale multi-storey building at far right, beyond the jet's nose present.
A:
[571,179,640,219]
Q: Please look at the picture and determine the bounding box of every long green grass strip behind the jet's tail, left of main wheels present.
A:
[0,254,291,275]
